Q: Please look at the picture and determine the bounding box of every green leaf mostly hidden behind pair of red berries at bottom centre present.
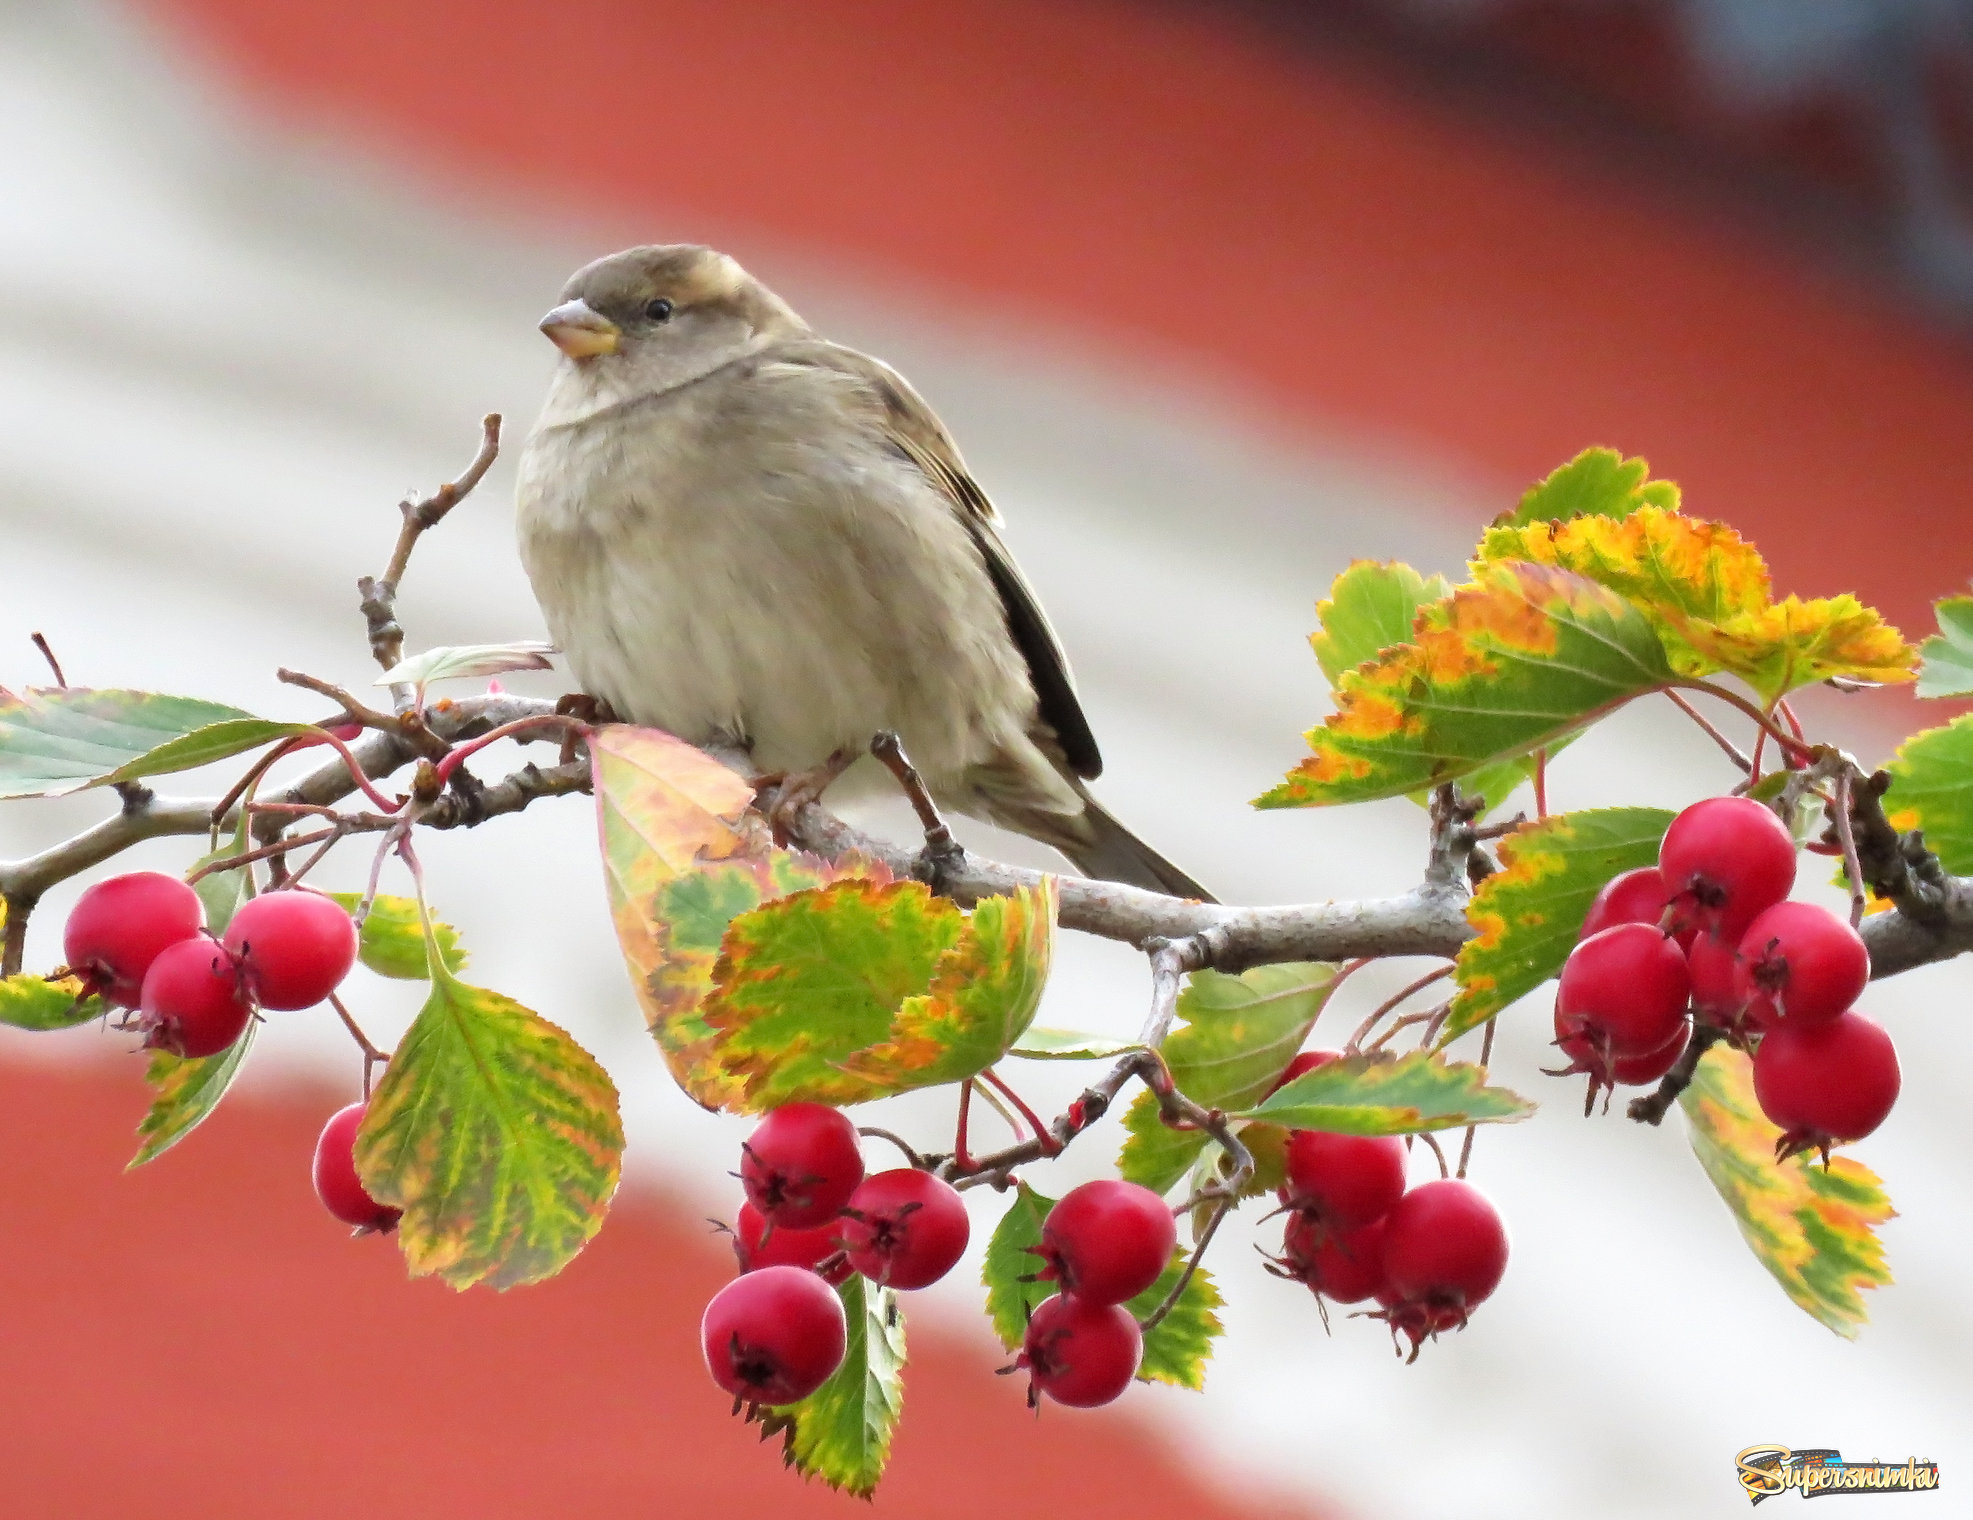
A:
[981,1182,1225,1388]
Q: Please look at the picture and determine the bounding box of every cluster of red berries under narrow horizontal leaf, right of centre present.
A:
[1275,1050,1507,1360]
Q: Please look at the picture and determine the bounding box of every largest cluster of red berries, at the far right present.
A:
[1555,798,1900,1157]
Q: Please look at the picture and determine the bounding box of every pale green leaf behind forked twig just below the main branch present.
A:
[1117,961,1336,1192]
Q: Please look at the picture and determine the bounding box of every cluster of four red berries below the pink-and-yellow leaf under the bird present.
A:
[698,1103,971,1404]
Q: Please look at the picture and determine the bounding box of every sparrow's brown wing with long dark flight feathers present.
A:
[771,340,1103,780]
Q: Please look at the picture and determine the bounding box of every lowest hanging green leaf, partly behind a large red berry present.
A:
[762,1273,904,1498]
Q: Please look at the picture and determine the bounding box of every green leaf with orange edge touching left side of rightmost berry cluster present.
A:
[1438,807,1671,1046]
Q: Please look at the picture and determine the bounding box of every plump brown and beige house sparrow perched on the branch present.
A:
[517,245,1209,900]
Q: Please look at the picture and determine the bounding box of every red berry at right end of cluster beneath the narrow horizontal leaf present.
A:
[1377,1178,1507,1358]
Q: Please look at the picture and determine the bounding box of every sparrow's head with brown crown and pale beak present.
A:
[541,243,807,393]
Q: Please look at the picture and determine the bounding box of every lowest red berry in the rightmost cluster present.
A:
[1754,1009,1900,1157]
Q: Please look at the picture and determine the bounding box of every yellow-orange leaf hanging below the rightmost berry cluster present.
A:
[1679,1044,1896,1340]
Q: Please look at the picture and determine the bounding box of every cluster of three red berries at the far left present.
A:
[63,871,357,1056]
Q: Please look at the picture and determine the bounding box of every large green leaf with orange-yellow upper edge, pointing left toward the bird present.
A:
[1257,561,1673,807]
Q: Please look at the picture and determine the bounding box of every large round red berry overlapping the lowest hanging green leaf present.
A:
[698,1267,848,1404]
